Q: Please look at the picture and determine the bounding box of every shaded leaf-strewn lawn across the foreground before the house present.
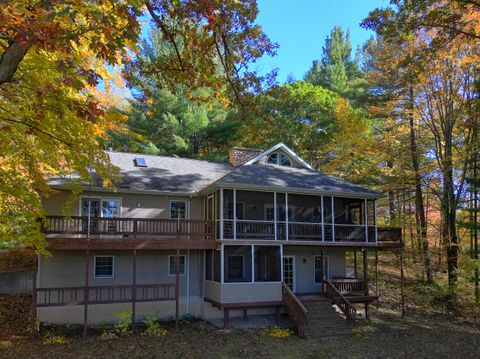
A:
[0,300,480,359]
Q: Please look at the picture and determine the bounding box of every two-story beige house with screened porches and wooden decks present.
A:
[34,143,401,338]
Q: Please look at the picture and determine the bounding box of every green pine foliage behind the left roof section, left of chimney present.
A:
[106,31,244,158]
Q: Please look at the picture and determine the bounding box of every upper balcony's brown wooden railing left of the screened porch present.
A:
[42,216,215,238]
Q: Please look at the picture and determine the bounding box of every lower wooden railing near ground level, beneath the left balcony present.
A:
[36,283,175,307]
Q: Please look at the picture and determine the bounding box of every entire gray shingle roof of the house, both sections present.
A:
[49,151,381,197]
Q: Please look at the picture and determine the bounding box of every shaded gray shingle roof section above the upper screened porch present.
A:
[216,164,382,197]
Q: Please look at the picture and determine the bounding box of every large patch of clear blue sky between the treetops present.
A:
[257,0,389,83]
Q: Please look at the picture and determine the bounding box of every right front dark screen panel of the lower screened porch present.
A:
[254,246,281,282]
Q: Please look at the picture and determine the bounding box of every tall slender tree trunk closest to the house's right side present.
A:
[408,87,433,283]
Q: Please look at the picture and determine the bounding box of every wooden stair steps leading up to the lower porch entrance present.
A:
[298,295,352,339]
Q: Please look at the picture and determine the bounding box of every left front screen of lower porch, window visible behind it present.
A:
[223,246,252,283]
